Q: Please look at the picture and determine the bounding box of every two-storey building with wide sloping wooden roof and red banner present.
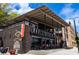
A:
[0,6,76,53]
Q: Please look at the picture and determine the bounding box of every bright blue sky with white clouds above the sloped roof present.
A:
[10,3,79,32]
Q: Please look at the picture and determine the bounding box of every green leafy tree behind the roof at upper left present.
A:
[0,3,19,26]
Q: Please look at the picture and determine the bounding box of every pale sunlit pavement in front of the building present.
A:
[23,47,79,55]
